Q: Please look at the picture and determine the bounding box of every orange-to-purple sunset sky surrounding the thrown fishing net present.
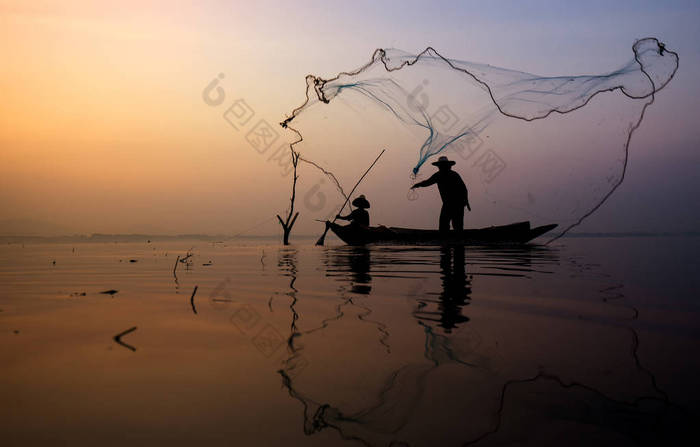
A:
[0,1,700,234]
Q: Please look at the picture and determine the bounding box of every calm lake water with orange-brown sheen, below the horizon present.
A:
[0,237,700,446]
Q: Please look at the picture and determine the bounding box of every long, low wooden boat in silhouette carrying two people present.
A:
[327,222,557,245]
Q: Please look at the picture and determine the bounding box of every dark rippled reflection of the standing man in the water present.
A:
[416,245,471,334]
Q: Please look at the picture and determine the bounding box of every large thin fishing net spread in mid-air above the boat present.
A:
[281,38,678,242]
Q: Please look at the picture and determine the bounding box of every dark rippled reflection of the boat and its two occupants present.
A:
[324,244,559,334]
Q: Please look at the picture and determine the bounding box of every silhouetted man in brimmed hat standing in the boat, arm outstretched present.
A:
[411,156,472,233]
